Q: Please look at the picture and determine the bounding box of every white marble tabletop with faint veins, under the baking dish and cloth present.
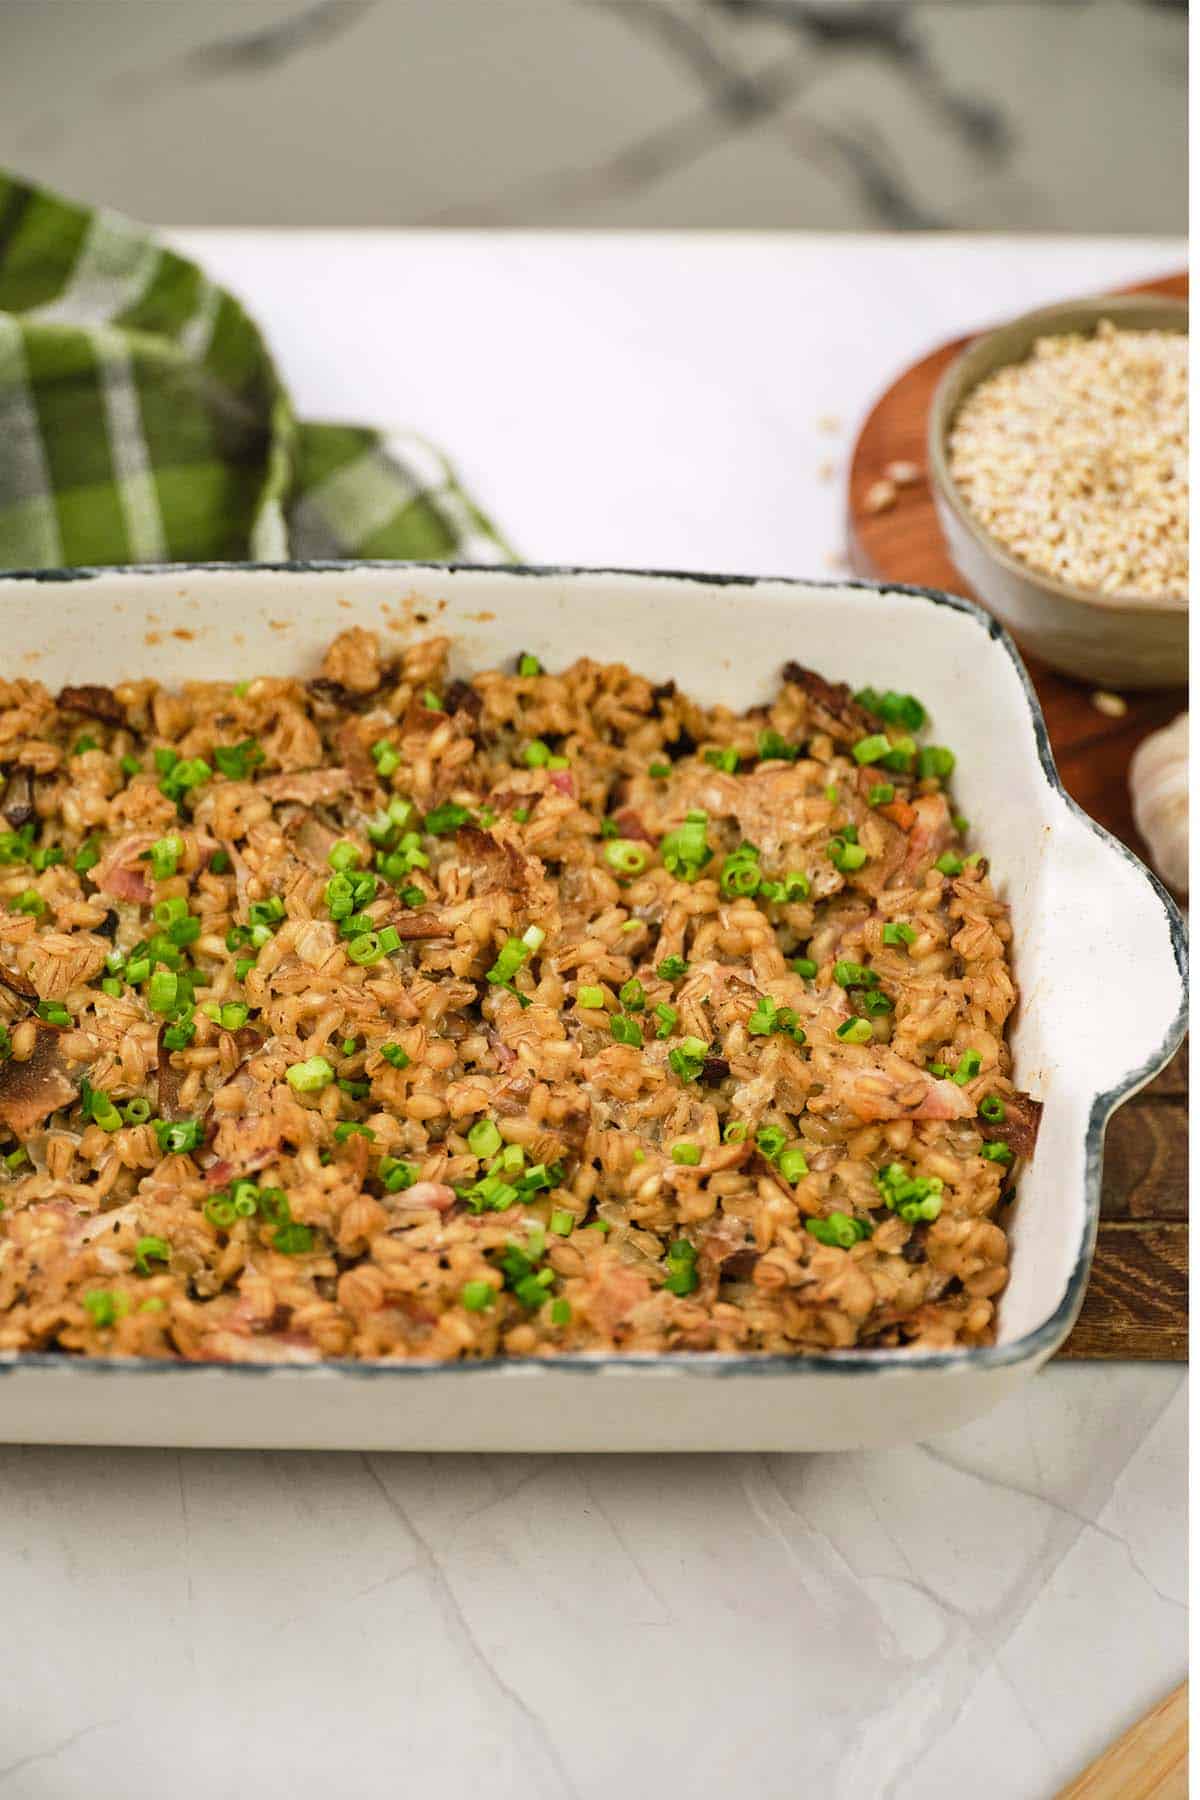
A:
[0,232,1186,1800]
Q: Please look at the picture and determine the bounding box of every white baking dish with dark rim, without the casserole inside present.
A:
[0,563,1186,1451]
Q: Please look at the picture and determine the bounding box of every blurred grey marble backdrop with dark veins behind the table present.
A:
[0,0,1186,232]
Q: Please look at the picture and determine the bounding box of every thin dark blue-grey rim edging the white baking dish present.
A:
[0,558,1187,1381]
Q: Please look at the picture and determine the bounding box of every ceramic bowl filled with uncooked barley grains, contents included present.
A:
[928,295,1187,688]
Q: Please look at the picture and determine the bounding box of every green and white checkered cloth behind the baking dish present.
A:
[0,175,511,569]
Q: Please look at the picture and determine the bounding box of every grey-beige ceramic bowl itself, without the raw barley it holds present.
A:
[928,295,1187,688]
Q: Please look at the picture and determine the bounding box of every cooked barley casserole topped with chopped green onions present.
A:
[0,628,1038,1363]
